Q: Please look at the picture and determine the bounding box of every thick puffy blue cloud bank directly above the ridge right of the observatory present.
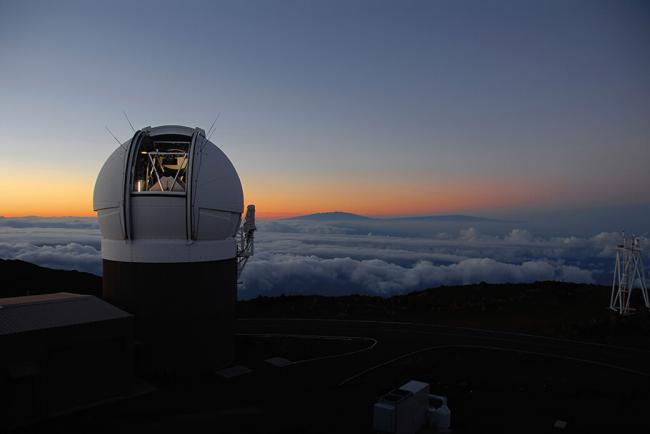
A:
[241,254,593,298]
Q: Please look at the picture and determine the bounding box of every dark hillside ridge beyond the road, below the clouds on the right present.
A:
[238,282,650,347]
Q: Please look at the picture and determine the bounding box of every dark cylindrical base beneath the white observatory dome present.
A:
[103,258,237,374]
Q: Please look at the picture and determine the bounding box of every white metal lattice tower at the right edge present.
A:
[609,234,650,315]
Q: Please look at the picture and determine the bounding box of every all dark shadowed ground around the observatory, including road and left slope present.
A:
[1,261,650,433]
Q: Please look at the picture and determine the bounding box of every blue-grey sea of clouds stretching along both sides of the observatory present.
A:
[0,217,632,298]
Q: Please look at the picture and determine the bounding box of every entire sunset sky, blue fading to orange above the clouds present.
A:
[0,0,650,217]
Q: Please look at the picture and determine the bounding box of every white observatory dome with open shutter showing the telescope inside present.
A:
[93,125,244,262]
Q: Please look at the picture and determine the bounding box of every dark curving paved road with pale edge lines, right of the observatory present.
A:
[238,318,650,384]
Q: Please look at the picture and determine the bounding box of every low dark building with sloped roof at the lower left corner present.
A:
[0,293,133,432]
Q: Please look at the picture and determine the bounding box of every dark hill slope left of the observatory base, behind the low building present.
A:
[0,259,102,297]
